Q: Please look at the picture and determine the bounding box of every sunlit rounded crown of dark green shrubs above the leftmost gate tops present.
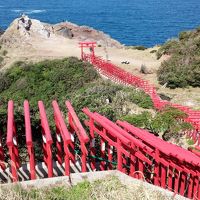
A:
[0,58,98,105]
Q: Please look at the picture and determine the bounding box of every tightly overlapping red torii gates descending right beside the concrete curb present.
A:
[83,108,200,198]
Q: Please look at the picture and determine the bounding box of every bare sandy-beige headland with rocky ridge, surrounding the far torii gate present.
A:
[0,16,200,109]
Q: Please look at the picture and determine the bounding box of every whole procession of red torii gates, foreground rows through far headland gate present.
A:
[0,43,200,199]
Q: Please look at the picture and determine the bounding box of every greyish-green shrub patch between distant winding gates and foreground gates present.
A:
[71,80,152,120]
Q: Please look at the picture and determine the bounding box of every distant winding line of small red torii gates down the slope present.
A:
[82,48,200,146]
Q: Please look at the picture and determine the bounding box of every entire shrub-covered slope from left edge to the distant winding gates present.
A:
[0,58,153,162]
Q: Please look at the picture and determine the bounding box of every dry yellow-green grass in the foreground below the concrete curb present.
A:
[0,176,175,200]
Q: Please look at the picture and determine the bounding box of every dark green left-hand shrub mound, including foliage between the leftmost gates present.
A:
[0,58,98,163]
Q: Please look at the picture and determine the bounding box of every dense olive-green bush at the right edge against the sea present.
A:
[157,28,200,88]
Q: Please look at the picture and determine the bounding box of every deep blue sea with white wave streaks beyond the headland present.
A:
[0,0,200,47]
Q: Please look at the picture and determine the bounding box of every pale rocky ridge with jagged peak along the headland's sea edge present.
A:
[0,15,123,48]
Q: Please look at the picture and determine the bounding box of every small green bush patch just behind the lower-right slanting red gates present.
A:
[121,107,192,140]
